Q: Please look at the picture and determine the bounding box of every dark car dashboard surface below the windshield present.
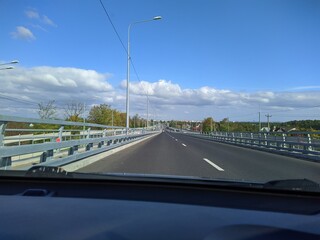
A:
[0,177,320,240]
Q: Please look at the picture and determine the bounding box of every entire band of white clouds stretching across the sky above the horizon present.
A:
[0,66,320,121]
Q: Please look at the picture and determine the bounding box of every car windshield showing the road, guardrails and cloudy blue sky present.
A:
[0,0,320,189]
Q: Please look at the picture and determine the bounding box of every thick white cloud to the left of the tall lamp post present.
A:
[0,66,115,114]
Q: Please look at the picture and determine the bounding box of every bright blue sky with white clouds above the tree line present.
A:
[0,0,320,121]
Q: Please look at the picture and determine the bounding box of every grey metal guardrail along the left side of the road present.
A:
[0,115,159,169]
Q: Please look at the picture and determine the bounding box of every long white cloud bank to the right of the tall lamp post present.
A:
[121,80,320,120]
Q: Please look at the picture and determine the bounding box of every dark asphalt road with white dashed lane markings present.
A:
[78,132,320,182]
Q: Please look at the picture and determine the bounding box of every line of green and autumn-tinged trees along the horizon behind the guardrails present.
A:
[8,100,320,135]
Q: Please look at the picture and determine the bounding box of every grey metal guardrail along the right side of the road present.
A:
[178,129,320,161]
